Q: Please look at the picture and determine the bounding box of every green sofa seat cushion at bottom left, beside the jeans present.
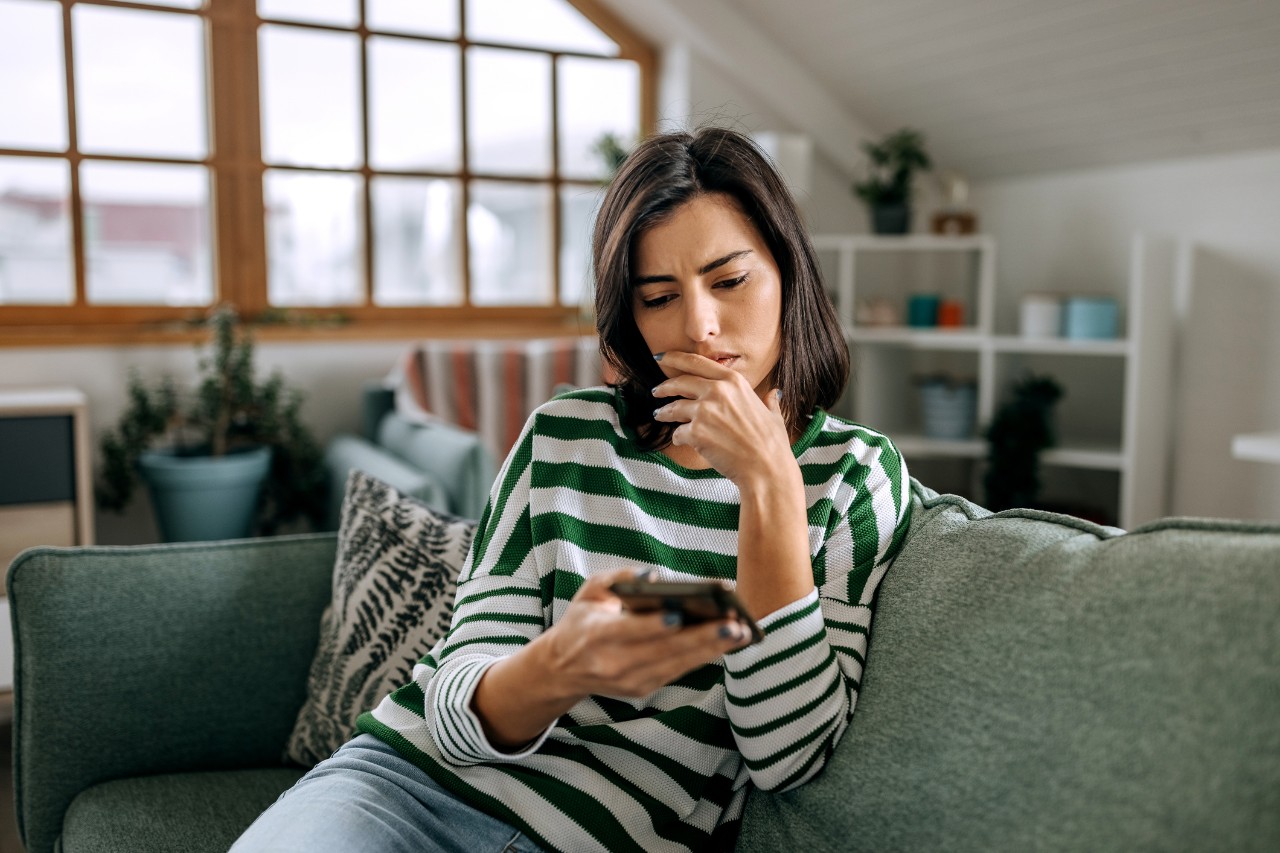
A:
[60,768,302,853]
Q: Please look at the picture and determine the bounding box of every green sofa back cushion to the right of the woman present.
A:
[740,483,1280,850]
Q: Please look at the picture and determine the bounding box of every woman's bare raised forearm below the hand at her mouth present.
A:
[737,457,813,619]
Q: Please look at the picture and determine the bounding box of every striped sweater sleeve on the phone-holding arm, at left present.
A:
[421,415,552,765]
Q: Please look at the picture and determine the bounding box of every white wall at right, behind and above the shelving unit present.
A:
[973,150,1280,520]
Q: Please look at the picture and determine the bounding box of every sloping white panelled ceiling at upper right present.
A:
[685,0,1280,178]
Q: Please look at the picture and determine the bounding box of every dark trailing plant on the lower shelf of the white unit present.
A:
[983,374,1062,512]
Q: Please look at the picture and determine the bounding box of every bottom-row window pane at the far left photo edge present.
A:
[0,158,76,305]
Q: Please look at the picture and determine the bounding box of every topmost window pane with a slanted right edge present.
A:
[467,0,618,56]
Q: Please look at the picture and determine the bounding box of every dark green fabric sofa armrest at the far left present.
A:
[8,534,337,853]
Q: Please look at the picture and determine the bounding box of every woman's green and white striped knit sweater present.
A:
[358,388,909,852]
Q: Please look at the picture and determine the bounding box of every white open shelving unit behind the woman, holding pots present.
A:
[814,234,1179,528]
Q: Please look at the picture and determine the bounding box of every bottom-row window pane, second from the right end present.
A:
[467,181,554,305]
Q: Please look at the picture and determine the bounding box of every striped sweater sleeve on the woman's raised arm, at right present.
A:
[724,429,910,790]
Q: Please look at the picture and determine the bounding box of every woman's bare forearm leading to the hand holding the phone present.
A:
[471,634,582,752]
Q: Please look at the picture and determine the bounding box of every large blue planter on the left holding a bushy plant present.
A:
[138,447,271,542]
